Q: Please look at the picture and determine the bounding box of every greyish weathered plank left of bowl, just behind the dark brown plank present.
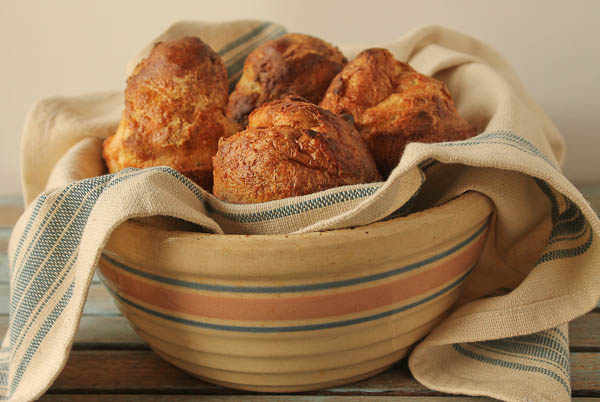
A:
[0,315,143,350]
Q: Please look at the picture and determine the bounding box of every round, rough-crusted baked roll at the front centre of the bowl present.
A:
[213,97,381,204]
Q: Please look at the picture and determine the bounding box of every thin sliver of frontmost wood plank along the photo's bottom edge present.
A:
[39,394,502,402]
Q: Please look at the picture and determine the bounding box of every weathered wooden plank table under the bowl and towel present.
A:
[0,184,600,402]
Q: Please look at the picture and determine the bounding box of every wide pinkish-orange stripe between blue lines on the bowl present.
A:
[100,229,486,321]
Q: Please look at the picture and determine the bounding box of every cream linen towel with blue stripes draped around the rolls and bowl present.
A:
[0,21,600,401]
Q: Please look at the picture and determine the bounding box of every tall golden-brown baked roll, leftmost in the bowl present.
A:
[102,36,239,190]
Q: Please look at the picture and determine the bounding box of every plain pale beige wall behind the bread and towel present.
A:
[0,0,600,195]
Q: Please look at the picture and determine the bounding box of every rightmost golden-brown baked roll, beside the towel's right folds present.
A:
[320,49,476,176]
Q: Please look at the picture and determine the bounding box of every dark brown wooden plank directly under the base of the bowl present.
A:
[44,351,600,396]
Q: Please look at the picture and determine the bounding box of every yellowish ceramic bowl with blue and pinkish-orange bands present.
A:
[99,193,493,392]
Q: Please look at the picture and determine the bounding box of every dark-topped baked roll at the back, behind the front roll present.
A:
[227,34,346,126]
